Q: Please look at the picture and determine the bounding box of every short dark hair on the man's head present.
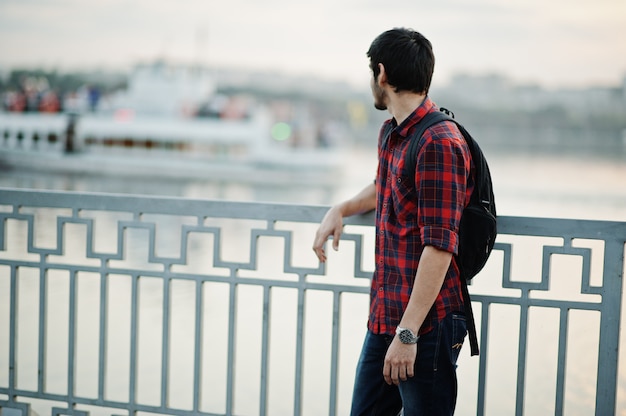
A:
[367,28,435,94]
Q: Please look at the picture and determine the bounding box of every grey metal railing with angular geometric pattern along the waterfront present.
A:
[0,189,626,415]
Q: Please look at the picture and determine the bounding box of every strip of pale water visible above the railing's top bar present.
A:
[0,147,626,221]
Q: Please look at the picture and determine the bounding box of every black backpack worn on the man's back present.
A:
[385,108,497,355]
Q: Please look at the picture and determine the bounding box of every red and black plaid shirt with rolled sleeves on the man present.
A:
[368,97,474,335]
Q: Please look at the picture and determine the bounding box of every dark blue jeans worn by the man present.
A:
[351,313,467,416]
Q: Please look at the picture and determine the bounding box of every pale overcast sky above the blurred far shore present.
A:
[0,0,626,88]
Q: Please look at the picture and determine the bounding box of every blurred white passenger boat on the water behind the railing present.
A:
[0,64,341,182]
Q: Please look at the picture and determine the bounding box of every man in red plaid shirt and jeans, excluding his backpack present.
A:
[313,29,474,416]
